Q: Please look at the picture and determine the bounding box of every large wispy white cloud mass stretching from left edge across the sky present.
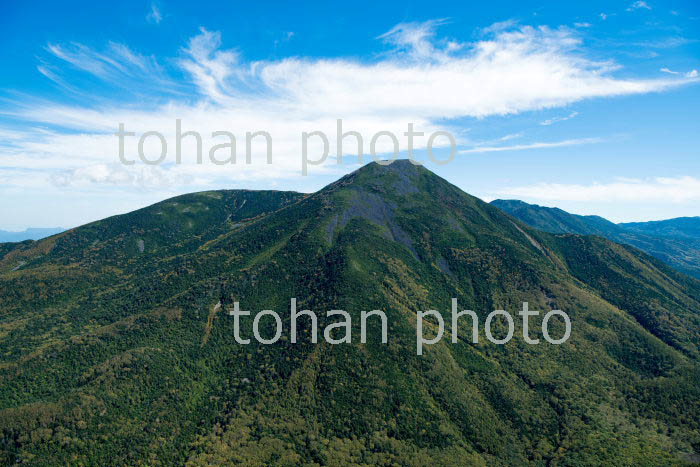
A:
[0,20,692,186]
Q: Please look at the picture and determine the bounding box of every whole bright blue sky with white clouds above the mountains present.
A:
[0,0,700,230]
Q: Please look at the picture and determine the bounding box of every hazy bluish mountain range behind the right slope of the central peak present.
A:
[491,199,700,278]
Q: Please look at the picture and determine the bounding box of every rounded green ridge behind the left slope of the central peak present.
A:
[0,190,304,271]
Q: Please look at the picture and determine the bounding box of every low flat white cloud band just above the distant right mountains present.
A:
[498,176,700,203]
